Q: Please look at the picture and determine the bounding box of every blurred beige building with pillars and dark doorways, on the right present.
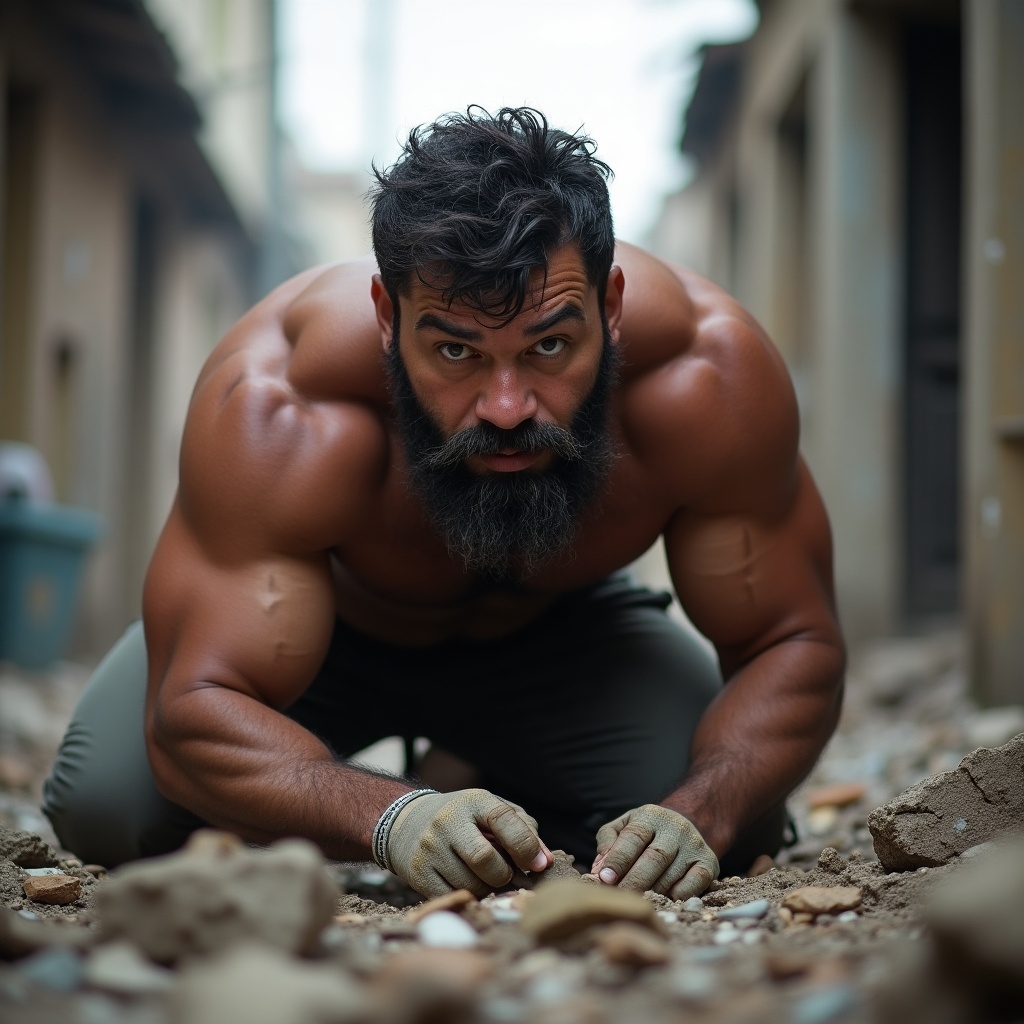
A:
[654,0,1024,700]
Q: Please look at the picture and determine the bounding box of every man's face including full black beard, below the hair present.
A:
[378,247,622,581]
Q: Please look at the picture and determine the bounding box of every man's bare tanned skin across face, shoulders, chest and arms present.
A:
[143,245,844,878]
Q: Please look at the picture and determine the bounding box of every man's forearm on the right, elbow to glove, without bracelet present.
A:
[660,639,844,857]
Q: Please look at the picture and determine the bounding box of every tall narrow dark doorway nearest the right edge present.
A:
[903,25,962,620]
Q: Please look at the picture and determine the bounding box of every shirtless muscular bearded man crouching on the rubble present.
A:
[46,109,844,898]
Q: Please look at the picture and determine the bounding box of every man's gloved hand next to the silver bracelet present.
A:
[387,790,553,896]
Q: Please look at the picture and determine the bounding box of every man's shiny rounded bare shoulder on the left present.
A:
[180,264,388,548]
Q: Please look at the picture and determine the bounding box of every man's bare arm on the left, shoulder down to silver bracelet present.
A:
[143,333,409,858]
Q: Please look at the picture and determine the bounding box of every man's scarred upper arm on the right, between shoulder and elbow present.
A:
[666,464,838,677]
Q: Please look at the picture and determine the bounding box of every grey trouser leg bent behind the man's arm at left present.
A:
[43,623,203,867]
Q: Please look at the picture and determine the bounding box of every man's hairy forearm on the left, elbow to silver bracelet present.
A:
[148,687,411,860]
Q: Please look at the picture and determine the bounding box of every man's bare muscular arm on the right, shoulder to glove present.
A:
[662,316,845,857]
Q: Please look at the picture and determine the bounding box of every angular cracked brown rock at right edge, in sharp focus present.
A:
[867,734,1024,871]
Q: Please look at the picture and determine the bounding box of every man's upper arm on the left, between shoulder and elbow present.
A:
[143,499,334,709]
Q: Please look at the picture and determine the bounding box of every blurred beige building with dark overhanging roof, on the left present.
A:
[0,0,291,652]
